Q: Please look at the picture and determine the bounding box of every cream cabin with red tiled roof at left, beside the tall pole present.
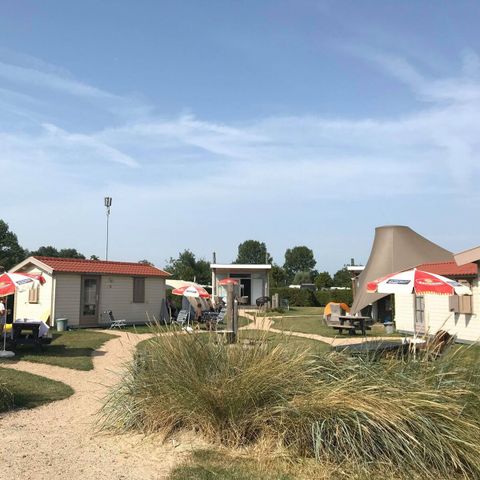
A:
[10,256,169,327]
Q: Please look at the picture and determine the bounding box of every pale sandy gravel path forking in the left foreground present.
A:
[0,330,199,480]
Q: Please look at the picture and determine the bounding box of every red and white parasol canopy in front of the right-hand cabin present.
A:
[367,268,472,295]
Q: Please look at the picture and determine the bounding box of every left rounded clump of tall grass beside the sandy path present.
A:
[103,334,315,445]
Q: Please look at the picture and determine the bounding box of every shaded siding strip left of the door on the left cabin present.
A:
[54,273,81,326]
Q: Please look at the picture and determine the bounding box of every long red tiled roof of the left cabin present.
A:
[33,257,170,277]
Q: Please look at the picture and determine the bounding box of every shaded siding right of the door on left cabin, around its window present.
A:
[99,275,165,323]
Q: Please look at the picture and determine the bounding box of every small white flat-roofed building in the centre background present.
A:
[210,263,272,305]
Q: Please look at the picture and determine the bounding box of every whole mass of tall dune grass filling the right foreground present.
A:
[102,334,480,478]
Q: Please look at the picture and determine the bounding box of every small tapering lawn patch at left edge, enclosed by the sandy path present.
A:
[0,368,73,412]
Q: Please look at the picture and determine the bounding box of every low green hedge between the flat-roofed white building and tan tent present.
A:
[270,287,353,307]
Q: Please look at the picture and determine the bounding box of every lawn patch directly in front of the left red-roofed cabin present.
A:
[0,329,114,370]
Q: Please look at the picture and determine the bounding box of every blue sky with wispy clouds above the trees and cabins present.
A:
[0,0,480,272]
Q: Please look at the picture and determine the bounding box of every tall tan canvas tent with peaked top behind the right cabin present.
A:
[351,225,453,313]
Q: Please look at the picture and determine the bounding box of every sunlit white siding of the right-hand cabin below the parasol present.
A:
[395,278,480,342]
